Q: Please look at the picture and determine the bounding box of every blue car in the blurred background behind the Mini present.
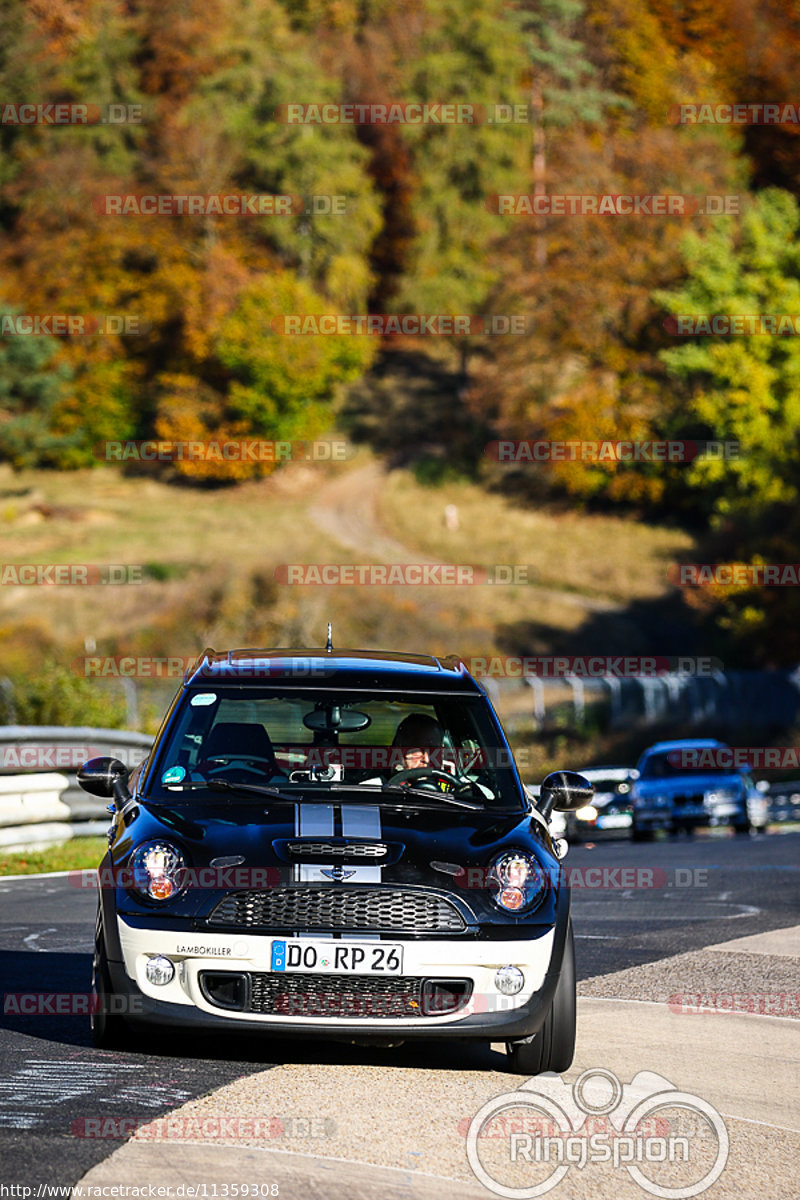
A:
[631,738,769,841]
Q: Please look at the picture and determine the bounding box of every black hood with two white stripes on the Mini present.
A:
[112,797,560,922]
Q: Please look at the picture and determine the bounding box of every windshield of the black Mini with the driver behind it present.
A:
[148,686,523,809]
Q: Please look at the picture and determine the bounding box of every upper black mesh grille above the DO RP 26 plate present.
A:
[207,884,467,934]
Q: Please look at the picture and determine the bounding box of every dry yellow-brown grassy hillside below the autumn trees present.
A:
[0,450,691,732]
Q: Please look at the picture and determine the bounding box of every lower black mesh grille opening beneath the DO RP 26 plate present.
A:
[200,971,473,1021]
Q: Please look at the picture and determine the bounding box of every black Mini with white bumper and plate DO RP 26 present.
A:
[79,649,591,1074]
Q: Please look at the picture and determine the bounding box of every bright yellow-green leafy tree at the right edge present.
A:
[654,188,800,516]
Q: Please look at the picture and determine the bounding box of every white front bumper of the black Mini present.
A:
[109,899,569,1040]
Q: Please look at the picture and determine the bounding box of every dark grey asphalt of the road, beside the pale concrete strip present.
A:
[0,833,800,1187]
